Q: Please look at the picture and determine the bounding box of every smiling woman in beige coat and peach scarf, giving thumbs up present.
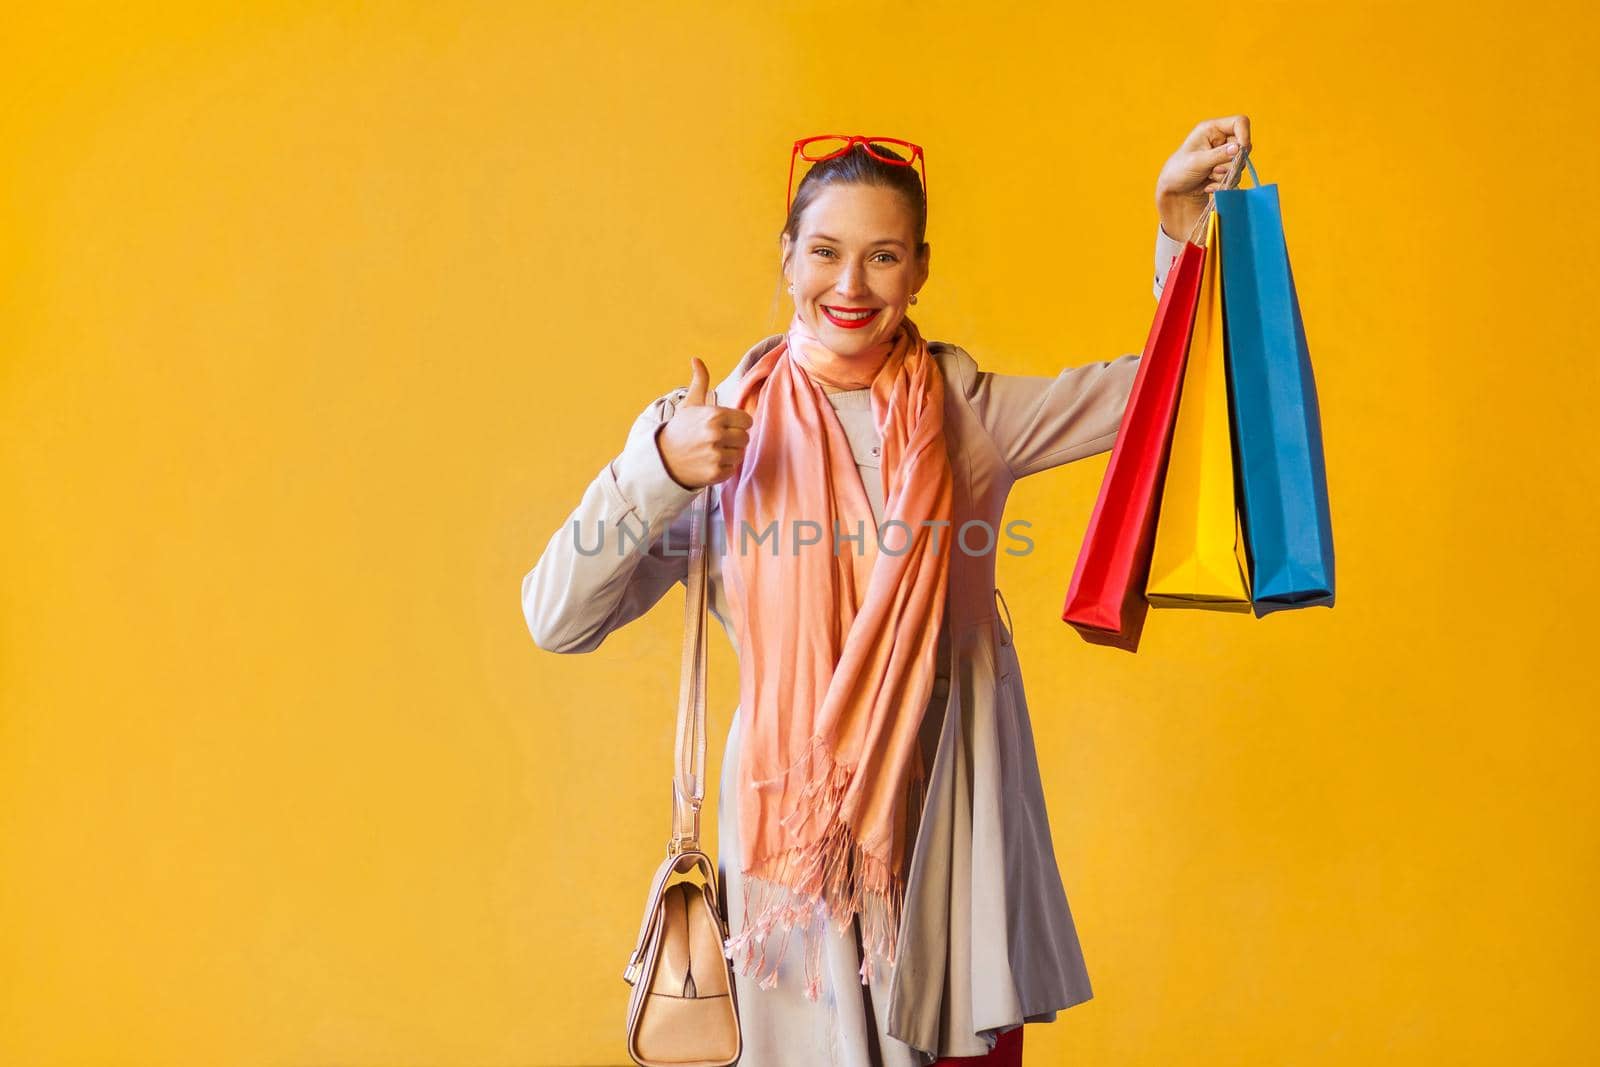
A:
[522,115,1250,1067]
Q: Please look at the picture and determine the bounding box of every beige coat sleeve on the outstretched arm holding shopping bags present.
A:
[957,222,1184,478]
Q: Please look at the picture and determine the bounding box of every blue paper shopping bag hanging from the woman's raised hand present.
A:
[1214,157,1333,617]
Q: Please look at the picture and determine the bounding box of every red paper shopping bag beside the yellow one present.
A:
[1061,242,1205,651]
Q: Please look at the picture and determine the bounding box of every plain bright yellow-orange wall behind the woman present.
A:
[0,2,1600,1067]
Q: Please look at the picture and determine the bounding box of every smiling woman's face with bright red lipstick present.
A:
[782,184,928,357]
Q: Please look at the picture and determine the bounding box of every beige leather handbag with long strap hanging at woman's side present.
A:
[622,488,744,1067]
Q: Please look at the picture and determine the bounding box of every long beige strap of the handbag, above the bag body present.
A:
[667,486,712,856]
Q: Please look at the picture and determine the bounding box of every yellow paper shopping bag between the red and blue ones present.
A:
[1144,211,1250,611]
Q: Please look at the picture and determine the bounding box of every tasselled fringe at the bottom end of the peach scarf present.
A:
[723,749,906,1001]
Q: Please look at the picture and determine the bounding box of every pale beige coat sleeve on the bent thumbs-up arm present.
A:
[522,389,698,653]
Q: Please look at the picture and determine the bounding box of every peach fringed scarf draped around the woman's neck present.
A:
[718,315,954,1000]
